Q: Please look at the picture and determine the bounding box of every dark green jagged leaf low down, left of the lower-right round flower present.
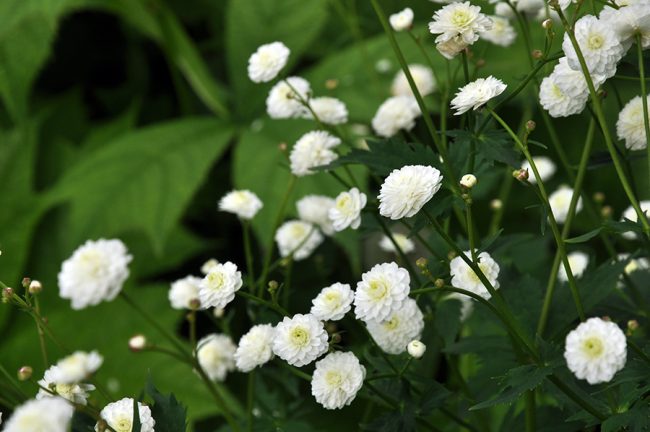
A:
[470,365,553,411]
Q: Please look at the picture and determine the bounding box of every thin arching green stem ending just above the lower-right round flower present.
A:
[487,107,585,321]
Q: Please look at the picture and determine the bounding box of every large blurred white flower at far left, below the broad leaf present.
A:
[58,239,133,309]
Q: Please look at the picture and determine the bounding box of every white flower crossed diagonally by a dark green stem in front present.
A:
[449,251,500,299]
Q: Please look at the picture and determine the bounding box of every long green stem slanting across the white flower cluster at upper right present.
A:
[555,6,650,238]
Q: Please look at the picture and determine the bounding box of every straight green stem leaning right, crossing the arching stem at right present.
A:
[537,119,596,336]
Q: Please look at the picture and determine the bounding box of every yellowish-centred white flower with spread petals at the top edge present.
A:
[429,2,492,57]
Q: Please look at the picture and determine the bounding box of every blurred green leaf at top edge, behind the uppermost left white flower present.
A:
[226,0,327,117]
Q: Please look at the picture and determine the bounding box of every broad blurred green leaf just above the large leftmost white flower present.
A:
[52,118,231,251]
